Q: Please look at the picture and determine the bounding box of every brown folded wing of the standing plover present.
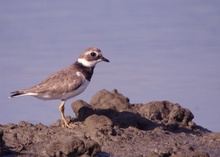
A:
[23,68,85,95]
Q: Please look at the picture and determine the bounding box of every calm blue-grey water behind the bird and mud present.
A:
[0,0,220,132]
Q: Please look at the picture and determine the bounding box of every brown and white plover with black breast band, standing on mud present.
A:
[9,47,109,128]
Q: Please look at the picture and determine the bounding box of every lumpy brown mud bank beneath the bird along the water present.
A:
[0,90,220,157]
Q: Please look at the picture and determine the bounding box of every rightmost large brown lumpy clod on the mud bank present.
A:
[138,101,195,129]
